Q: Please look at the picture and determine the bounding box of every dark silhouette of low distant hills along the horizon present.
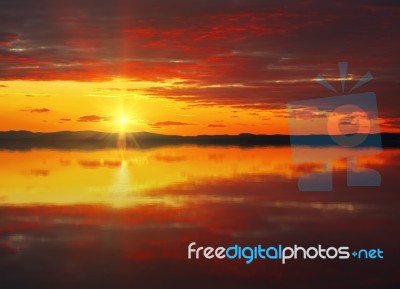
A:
[0,131,400,150]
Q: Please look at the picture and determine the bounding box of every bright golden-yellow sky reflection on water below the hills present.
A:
[0,146,390,206]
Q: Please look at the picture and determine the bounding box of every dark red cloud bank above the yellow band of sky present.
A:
[0,0,400,129]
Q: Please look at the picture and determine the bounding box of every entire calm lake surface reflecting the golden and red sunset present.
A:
[0,146,400,288]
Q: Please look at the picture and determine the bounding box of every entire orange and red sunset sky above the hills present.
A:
[0,0,400,135]
